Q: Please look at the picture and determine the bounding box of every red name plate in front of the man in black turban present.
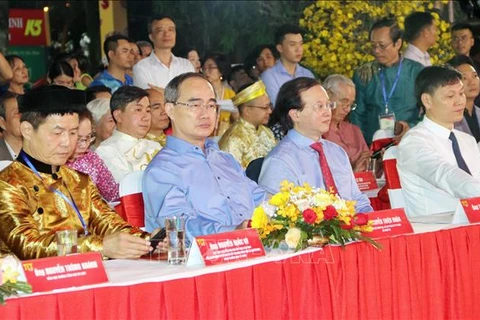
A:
[22,252,108,292]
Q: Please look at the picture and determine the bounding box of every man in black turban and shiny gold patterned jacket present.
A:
[0,86,158,259]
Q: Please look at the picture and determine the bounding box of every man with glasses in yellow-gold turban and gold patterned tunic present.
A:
[218,81,276,168]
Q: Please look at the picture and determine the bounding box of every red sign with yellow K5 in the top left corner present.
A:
[8,9,50,46]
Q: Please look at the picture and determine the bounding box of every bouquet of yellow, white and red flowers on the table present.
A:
[251,181,380,251]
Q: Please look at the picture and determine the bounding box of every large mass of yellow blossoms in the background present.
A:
[300,0,454,78]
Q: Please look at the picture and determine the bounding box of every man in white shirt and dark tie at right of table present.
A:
[397,67,480,216]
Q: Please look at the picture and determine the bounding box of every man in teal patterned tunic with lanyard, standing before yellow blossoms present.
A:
[350,19,423,144]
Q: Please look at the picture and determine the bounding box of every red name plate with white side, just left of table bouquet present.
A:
[187,229,265,266]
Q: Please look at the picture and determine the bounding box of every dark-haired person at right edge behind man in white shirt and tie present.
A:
[448,56,480,142]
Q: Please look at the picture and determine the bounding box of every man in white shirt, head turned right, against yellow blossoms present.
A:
[403,12,438,67]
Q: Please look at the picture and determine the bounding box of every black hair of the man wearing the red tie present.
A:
[269,77,320,132]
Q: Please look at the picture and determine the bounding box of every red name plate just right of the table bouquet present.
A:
[363,208,413,238]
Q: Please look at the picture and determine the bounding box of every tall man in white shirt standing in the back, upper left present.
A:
[133,16,195,89]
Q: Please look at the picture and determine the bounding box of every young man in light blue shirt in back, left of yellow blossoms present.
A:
[260,25,314,105]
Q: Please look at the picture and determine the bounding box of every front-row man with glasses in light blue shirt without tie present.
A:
[143,73,266,240]
